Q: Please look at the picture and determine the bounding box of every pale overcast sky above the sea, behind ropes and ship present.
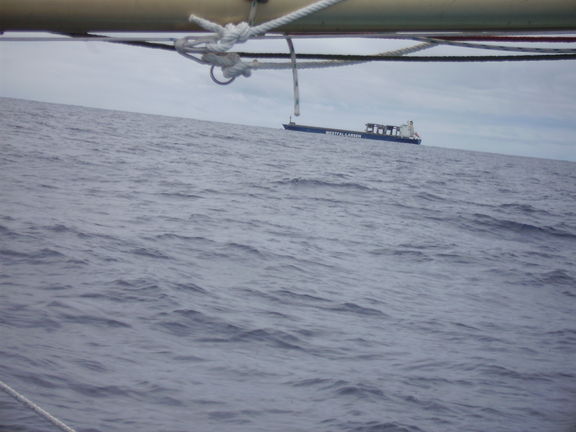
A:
[0,32,576,161]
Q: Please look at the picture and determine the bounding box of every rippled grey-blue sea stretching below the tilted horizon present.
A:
[0,99,576,432]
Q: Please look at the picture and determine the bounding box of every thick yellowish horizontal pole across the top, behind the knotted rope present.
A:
[0,0,576,33]
